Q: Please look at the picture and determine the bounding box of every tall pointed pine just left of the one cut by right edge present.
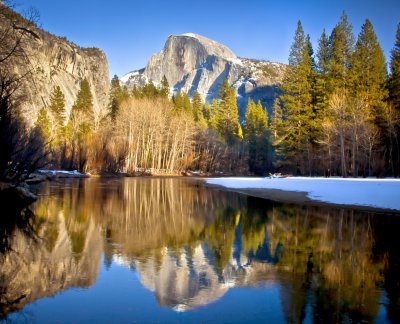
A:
[348,19,387,176]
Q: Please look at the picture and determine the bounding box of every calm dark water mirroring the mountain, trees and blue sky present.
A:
[0,178,400,323]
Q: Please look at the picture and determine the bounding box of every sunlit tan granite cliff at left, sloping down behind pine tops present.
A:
[0,4,109,125]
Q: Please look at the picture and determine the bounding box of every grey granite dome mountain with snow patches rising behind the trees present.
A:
[121,34,285,115]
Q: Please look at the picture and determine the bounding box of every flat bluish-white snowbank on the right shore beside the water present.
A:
[207,177,400,210]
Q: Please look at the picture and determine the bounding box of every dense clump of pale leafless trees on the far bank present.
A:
[109,98,195,174]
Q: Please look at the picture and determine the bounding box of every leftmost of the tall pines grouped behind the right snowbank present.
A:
[280,21,314,173]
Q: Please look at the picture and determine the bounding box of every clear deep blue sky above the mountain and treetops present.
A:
[18,0,400,77]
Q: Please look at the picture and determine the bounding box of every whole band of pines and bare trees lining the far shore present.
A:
[0,4,400,179]
